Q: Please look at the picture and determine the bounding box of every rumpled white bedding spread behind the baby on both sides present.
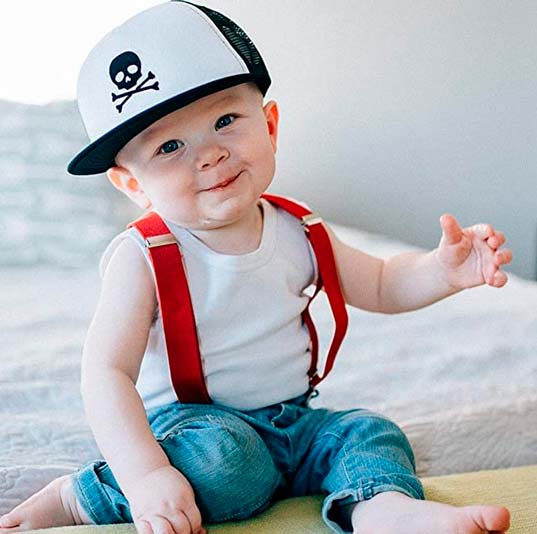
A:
[0,227,537,513]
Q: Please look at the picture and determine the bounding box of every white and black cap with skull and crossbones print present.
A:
[67,0,270,175]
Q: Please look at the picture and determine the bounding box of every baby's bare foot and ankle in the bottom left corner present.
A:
[0,475,92,534]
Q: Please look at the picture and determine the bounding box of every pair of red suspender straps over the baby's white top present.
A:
[129,194,348,403]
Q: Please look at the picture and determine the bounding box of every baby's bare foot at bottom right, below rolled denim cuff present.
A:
[352,491,509,534]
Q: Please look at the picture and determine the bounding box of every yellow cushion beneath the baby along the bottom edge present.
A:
[32,465,537,534]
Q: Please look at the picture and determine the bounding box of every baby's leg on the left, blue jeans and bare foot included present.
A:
[0,405,282,534]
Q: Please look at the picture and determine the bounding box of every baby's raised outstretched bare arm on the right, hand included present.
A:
[322,215,512,313]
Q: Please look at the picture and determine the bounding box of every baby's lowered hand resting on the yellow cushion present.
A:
[125,465,206,534]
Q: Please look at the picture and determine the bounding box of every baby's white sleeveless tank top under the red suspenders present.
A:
[100,199,317,410]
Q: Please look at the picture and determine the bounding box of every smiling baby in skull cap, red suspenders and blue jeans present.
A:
[0,1,511,534]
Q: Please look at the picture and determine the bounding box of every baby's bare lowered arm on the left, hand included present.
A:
[81,239,203,534]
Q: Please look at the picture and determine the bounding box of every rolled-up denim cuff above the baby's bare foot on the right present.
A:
[322,475,425,534]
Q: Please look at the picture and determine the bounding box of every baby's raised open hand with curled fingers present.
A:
[435,215,513,289]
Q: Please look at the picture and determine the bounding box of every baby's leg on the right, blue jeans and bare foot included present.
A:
[295,410,509,534]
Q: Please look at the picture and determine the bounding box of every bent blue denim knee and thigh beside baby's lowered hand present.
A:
[152,405,283,523]
